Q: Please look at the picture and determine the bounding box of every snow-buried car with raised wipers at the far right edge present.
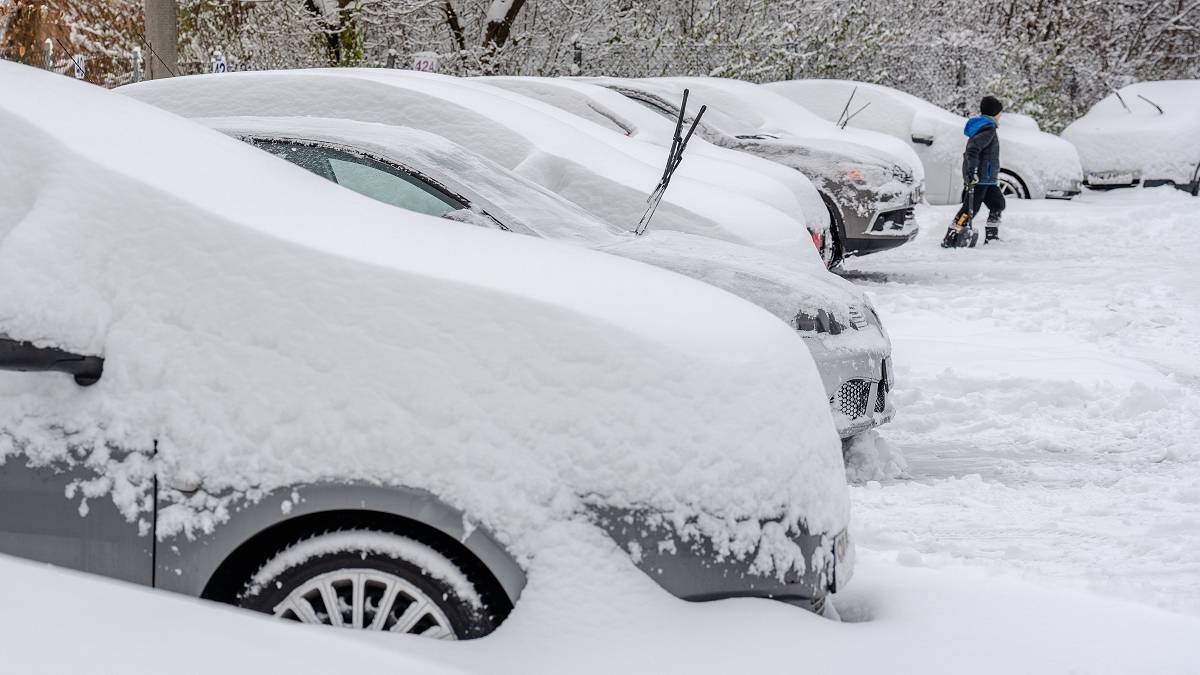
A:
[1062,79,1200,195]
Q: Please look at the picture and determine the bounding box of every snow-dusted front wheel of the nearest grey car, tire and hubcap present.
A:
[236,530,499,640]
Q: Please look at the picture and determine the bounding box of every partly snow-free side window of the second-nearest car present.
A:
[253,139,468,217]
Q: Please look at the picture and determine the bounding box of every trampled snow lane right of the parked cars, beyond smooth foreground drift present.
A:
[845,189,1200,615]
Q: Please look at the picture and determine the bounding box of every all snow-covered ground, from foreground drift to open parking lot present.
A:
[9,189,1200,675]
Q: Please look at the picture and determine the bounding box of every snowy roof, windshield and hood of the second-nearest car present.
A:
[198,118,866,325]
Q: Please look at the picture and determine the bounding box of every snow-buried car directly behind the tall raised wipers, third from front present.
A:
[118,68,816,256]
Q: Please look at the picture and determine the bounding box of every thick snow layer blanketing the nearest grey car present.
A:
[0,62,850,573]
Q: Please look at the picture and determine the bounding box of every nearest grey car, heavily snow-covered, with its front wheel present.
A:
[0,61,852,638]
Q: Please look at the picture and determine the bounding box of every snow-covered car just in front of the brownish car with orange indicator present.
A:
[478,76,840,267]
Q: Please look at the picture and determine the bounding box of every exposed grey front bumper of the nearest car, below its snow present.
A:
[593,507,853,598]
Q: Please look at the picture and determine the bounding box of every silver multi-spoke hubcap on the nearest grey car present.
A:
[275,569,457,640]
